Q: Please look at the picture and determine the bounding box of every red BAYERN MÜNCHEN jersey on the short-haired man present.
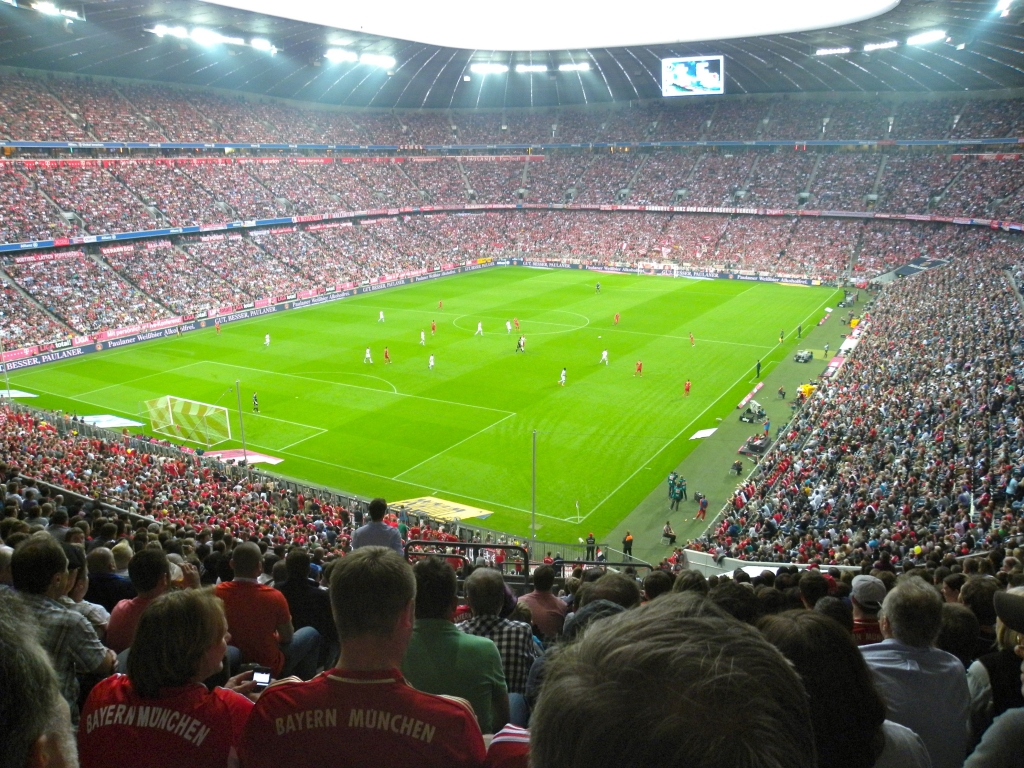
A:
[240,670,486,768]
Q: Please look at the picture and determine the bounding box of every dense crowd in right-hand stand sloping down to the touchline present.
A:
[691,249,1024,565]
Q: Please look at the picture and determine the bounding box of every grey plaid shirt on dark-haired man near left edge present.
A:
[18,592,106,723]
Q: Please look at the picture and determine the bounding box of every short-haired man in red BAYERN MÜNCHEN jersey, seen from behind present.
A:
[240,547,486,768]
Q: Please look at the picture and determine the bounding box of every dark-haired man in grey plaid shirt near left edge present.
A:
[11,535,117,723]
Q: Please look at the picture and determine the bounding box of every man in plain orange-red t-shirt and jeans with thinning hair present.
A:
[215,542,321,680]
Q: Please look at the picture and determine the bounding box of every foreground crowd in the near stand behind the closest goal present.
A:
[0,430,1024,768]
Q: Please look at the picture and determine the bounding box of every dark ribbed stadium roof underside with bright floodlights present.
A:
[6,0,1024,109]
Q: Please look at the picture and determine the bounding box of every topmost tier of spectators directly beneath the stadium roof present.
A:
[6,75,1024,146]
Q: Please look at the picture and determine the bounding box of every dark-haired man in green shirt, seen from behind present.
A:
[401,557,509,733]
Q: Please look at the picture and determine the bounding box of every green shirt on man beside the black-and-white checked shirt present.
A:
[401,618,508,733]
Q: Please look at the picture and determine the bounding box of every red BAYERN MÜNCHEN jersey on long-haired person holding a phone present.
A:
[78,675,253,768]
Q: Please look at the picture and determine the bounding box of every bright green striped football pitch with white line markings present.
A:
[10,267,838,541]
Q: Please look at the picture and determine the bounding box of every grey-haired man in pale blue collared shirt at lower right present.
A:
[860,575,970,768]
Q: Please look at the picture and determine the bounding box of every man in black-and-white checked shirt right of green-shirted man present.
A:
[460,568,540,693]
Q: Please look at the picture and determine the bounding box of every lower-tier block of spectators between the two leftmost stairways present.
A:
[4,252,166,334]
